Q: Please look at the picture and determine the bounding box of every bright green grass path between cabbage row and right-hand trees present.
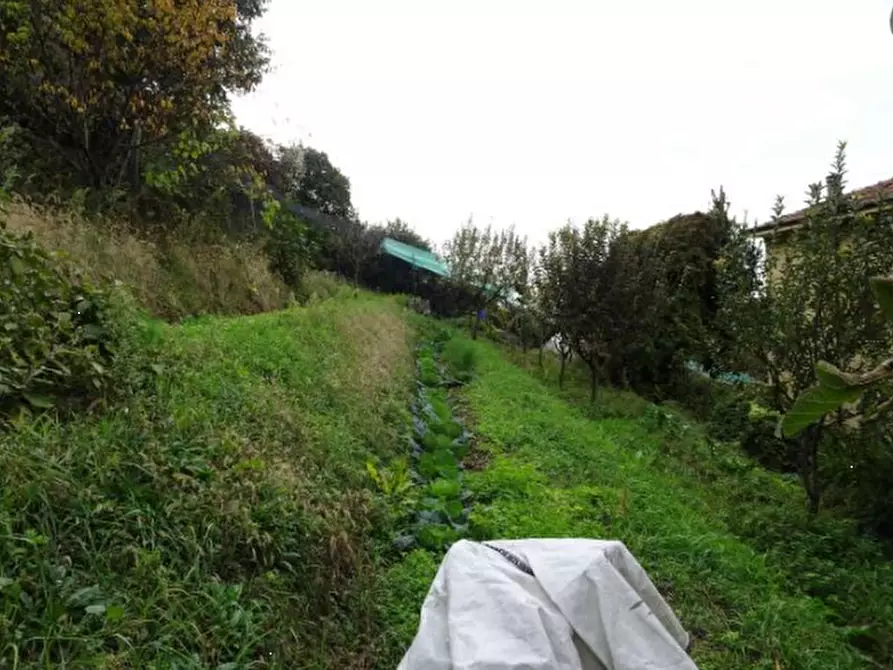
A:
[381,343,890,670]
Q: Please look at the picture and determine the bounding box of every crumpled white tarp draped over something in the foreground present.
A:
[398,540,696,670]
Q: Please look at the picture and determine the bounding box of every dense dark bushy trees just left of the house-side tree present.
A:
[533,207,729,399]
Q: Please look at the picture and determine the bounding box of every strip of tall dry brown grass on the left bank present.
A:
[6,202,291,319]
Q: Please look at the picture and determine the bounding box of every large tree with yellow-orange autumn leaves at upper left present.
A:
[0,0,267,188]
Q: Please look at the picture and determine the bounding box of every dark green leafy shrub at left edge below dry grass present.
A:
[0,227,115,416]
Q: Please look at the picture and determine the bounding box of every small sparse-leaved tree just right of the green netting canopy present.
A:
[445,219,530,337]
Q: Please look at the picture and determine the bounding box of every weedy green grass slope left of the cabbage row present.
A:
[0,297,412,669]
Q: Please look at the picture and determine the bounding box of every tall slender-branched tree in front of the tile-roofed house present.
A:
[723,143,893,512]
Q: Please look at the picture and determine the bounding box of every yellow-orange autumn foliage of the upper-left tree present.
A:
[9,0,247,148]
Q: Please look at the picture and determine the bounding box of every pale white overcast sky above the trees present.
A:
[234,0,893,243]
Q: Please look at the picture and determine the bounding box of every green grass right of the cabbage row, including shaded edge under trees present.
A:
[380,343,893,670]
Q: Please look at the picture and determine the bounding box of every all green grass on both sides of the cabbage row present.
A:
[0,294,893,670]
